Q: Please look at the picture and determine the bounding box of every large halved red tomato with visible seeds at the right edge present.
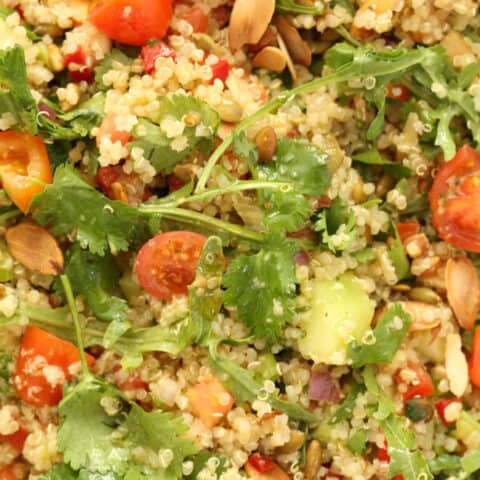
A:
[430,145,480,252]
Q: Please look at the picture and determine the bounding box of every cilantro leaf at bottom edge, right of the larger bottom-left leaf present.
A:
[124,403,198,478]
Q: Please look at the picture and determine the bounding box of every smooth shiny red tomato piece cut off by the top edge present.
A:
[89,0,173,46]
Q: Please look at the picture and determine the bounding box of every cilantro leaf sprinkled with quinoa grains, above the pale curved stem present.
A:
[129,94,220,174]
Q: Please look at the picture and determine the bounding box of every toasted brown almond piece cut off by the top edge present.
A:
[228,0,275,52]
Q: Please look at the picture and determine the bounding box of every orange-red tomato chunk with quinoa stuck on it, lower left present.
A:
[14,326,95,407]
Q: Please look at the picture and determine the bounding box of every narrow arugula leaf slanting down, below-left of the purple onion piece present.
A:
[207,339,318,423]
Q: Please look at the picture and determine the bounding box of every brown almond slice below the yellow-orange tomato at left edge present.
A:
[5,223,64,275]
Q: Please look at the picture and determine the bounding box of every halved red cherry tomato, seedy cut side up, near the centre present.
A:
[135,231,207,301]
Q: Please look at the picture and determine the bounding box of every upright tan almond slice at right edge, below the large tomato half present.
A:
[445,256,480,330]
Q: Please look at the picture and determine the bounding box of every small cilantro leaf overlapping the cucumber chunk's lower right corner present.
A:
[348,303,411,368]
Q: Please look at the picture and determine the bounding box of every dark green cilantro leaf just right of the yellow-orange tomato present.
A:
[30,165,146,255]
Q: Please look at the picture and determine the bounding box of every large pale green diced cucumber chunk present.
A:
[298,274,375,365]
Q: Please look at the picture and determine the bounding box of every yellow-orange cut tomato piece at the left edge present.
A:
[0,132,52,212]
